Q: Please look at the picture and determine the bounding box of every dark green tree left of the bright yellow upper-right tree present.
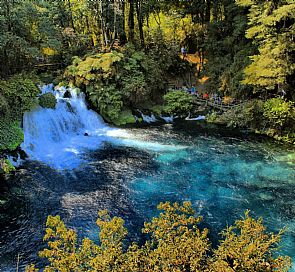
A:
[204,1,255,98]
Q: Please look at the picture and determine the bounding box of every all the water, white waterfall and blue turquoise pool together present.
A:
[0,86,295,271]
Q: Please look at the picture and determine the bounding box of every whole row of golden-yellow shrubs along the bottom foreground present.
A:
[26,202,291,272]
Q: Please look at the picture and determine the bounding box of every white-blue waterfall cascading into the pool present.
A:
[22,84,120,169]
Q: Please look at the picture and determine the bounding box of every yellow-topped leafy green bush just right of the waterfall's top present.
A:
[65,52,124,122]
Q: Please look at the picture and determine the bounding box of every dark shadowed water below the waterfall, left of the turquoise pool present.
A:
[0,144,157,271]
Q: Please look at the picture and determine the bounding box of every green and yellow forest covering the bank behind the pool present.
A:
[0,0,295,153]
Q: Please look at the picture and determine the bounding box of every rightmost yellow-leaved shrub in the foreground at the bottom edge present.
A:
[213,211,290,272]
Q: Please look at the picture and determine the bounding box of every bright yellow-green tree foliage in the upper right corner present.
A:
[236,0,295,91]
